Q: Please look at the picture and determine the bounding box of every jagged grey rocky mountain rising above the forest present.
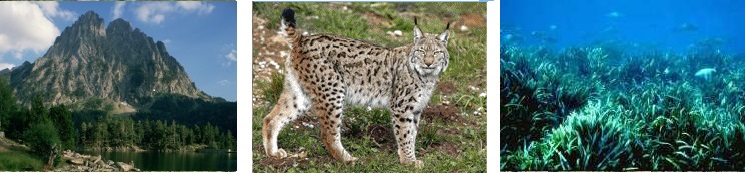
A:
[5,11,213,107]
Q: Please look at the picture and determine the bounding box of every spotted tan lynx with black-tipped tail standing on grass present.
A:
[262,8,450,167]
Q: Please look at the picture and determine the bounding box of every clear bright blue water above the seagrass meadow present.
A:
[500,0,745,54]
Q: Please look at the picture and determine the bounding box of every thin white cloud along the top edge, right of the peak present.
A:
[135,1,215,24]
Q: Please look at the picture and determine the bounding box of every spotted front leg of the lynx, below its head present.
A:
[391,110,424,168]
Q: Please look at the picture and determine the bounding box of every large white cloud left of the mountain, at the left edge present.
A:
[0,2,60,58]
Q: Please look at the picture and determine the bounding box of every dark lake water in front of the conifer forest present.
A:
[81,151,238,171]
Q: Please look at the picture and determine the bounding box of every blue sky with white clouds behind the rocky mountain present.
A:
[0,1,237,101]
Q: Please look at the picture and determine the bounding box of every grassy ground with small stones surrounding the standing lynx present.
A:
[252,3,486,172]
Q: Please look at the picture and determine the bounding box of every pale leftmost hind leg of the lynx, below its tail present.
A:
[262,79,309,158]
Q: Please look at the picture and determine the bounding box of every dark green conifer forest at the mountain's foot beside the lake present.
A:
[0,79,236,169]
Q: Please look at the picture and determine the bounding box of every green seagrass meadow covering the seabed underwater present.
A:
[500,43,745,171]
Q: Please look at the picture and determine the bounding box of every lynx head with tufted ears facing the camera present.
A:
[409,18,450,76]
